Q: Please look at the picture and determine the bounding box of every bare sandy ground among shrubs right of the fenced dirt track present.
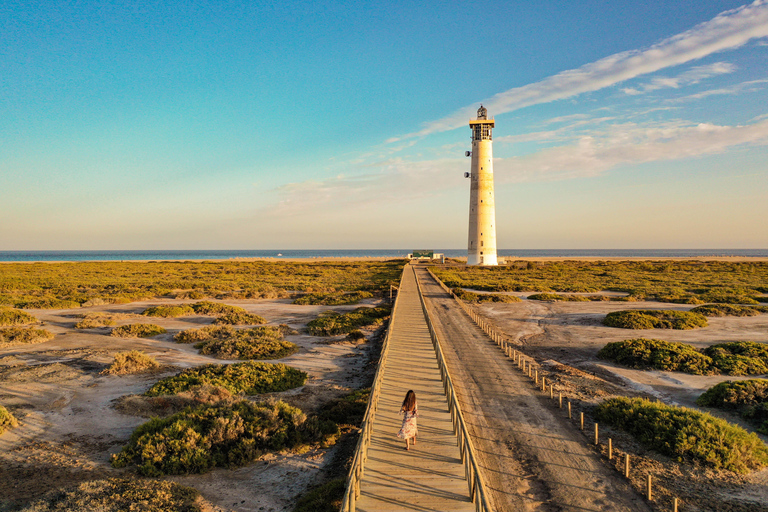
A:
[472,292,768,511]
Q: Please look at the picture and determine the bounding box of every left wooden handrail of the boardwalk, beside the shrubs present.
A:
[340,271,405,512]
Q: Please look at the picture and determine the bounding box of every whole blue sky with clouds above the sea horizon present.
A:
[0,0,768,250]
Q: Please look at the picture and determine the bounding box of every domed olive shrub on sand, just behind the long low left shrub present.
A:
[195,327,299,359]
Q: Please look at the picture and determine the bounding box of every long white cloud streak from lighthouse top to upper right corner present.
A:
[387,0,768,143]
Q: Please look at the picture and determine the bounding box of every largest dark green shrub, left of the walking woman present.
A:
[112,400,338,476]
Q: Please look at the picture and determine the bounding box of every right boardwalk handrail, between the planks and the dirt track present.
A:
[414,269,493,512]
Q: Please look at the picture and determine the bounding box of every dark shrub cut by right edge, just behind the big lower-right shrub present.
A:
[696,379,768,434]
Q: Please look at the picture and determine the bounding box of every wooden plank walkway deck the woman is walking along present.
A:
[356,266,474,512]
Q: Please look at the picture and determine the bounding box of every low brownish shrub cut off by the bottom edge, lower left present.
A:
[22,478,209,512]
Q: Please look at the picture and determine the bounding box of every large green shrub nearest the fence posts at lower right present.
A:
[595,397,768,473]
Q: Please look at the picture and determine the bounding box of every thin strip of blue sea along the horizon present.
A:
[0,248,768,262]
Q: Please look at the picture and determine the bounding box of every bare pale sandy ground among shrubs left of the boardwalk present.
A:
[0,300,380,512]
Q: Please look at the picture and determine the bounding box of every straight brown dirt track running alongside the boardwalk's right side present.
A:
[417,269,650,512]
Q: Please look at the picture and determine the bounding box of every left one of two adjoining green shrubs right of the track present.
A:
[597,338,714,375]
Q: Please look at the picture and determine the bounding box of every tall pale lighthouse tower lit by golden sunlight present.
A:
[464,105,498,265]
